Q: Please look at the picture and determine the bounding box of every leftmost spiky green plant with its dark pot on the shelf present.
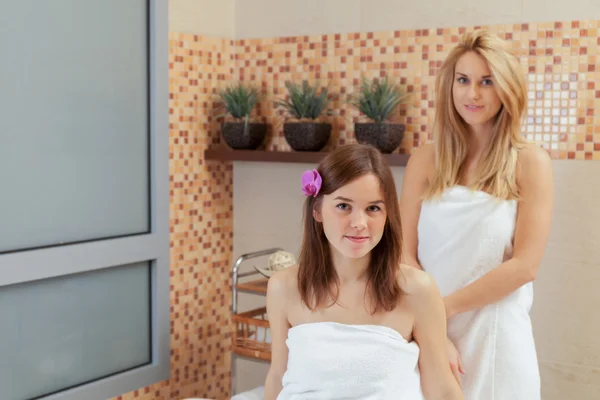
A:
[219,82,267,150]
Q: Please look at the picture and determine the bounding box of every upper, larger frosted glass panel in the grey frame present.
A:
[0,0,150,252]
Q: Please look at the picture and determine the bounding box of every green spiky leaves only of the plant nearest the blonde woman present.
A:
[350,76,409,124]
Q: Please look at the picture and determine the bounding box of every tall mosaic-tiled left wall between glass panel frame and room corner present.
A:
[114,33,233,400]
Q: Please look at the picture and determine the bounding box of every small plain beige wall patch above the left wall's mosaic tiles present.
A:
[169,0,234,38]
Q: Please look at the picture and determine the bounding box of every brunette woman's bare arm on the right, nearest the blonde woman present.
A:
[405,267,463,400]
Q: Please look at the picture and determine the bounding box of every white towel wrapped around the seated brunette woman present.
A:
[277,322,422,400]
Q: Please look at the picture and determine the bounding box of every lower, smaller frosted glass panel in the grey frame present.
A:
[0,263,151,400]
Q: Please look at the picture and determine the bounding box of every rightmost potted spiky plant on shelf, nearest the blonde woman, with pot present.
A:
[351,76,408,153]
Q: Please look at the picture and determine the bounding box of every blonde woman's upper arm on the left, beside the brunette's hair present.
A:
[400,145,435,269]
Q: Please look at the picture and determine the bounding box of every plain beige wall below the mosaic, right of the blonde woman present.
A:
[532,161,600,400]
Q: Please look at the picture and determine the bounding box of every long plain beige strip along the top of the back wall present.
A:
[234,0,600,39]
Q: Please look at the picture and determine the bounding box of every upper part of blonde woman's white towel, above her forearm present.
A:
[418,186,517,296]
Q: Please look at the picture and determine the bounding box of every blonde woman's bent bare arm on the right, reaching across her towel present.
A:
[444,146,554,318]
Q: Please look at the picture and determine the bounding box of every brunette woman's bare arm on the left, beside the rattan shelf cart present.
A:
[265,271,290,400]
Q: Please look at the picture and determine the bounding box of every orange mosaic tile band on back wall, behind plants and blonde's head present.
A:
[234,21,600,160]
